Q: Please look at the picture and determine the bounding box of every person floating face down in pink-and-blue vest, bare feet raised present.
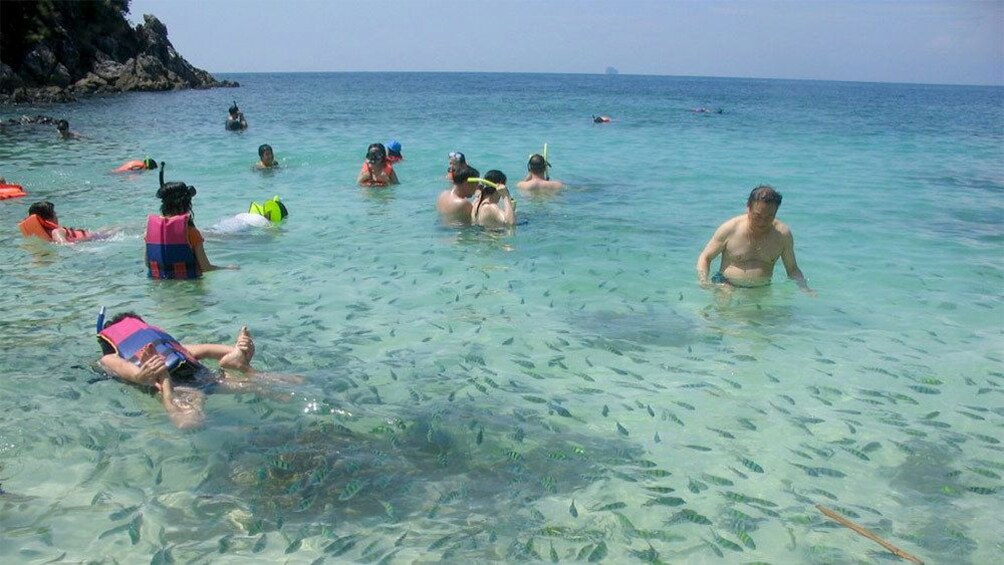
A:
[97,309,260,430]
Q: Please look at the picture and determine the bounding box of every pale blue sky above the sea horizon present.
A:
[130,0,1004,85]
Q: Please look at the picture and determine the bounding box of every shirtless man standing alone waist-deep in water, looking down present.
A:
[697,185,813,294]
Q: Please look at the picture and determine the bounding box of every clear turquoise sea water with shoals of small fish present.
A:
[0,74,1004,563]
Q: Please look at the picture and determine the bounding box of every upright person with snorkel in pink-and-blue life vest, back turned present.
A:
[144,162,237,279]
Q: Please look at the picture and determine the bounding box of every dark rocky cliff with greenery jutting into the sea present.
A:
[0,0,239,103]
